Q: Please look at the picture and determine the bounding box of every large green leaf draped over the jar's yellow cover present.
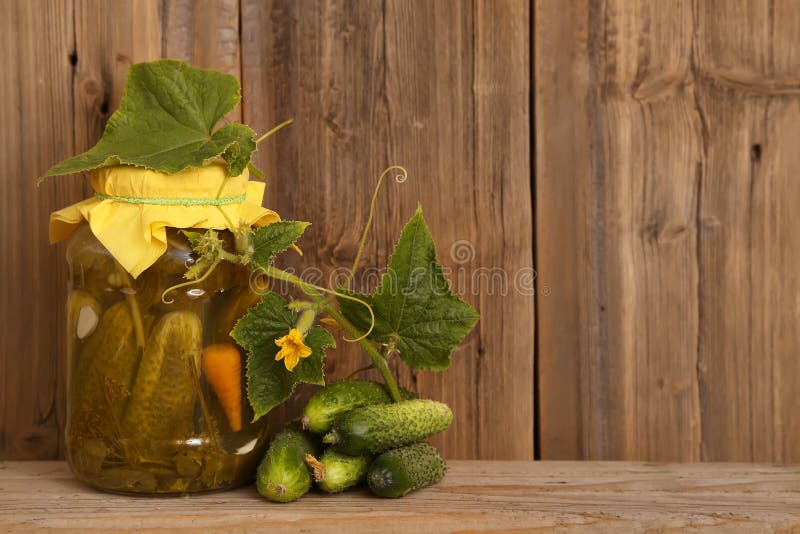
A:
[39,60,256,182]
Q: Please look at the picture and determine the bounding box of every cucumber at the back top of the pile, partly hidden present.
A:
[301,380,414,434]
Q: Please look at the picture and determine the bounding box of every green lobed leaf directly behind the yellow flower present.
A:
[231,292,336,421]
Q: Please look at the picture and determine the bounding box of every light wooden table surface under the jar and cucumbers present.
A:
[0,461,800,533]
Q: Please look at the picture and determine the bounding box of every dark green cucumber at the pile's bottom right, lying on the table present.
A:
[367,443,447,497]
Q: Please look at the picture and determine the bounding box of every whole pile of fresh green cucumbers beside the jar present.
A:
[256,380,453,502]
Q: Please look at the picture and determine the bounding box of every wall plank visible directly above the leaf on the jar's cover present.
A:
[75,0,241,151]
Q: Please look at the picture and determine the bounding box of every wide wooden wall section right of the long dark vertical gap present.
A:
[534,0,800,461]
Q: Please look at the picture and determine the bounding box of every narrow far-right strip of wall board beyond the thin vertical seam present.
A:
[695,1,800,462]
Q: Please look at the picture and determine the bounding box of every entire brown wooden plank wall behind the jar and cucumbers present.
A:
[0,0,800,462]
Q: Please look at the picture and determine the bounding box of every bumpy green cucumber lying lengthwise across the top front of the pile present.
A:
[322,399,453,456]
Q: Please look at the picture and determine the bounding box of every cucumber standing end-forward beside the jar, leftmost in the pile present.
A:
[256,425,320,502]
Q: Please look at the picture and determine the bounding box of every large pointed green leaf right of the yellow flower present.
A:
[338,207,479,371]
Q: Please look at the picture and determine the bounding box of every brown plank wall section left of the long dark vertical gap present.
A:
[0,0,534,459]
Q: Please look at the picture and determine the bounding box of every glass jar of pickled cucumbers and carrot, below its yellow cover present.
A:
[66,224,267,494]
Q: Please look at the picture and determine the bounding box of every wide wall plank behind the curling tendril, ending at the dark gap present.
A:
[242,0,533,459]
